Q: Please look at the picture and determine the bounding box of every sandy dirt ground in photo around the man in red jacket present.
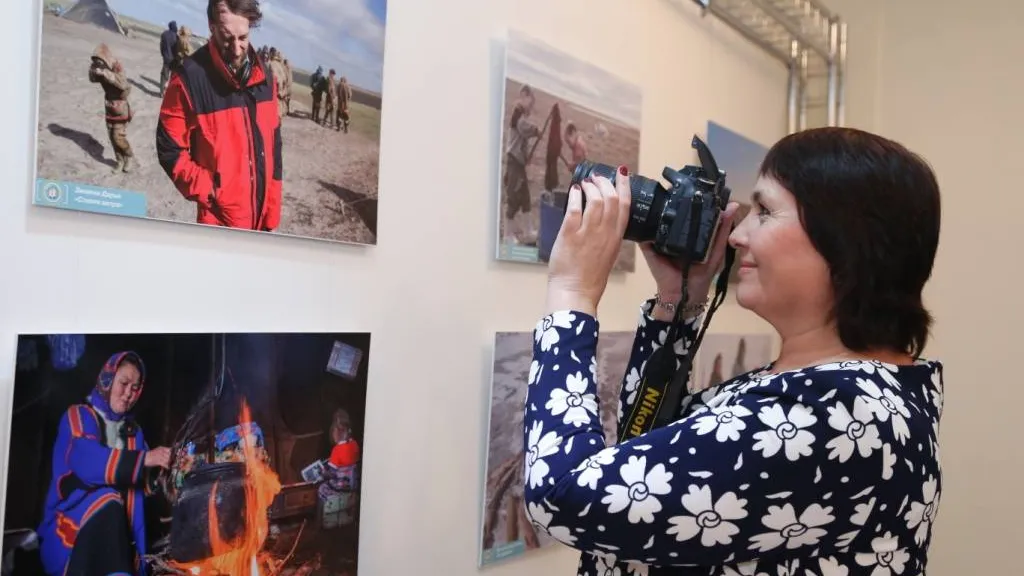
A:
[37,14,380,244]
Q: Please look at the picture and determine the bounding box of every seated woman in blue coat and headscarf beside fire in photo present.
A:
[38,352,171,576]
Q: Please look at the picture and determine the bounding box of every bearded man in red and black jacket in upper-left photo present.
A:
[157,0,283,232]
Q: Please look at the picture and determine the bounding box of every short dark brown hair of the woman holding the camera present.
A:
[761,128,941,358]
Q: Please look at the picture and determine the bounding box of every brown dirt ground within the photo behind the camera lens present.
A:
[499,79,640,272]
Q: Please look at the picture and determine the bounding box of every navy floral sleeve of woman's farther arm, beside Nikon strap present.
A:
[615,298,703,427]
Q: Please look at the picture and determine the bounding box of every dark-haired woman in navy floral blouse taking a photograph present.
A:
[524,128,942,576]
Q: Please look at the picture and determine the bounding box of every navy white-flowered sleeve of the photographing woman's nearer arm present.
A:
[524,312,877,566]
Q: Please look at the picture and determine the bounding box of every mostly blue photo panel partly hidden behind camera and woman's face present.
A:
[707,121,768,284]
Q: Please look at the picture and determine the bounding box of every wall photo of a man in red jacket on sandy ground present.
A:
[33,0,387,244]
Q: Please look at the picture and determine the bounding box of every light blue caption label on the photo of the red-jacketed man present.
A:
[32,178,145,218]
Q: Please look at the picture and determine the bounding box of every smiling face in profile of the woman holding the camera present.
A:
[729,177,833,328]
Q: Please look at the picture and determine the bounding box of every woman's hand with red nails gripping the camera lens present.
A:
[547,166,630,316]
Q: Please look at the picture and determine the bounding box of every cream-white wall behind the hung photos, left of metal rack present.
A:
[0,0,785,576]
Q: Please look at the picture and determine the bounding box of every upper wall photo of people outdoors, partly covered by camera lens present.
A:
[497,31,642,272]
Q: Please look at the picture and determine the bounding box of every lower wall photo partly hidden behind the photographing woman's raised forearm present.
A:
[479,331,636,566]
